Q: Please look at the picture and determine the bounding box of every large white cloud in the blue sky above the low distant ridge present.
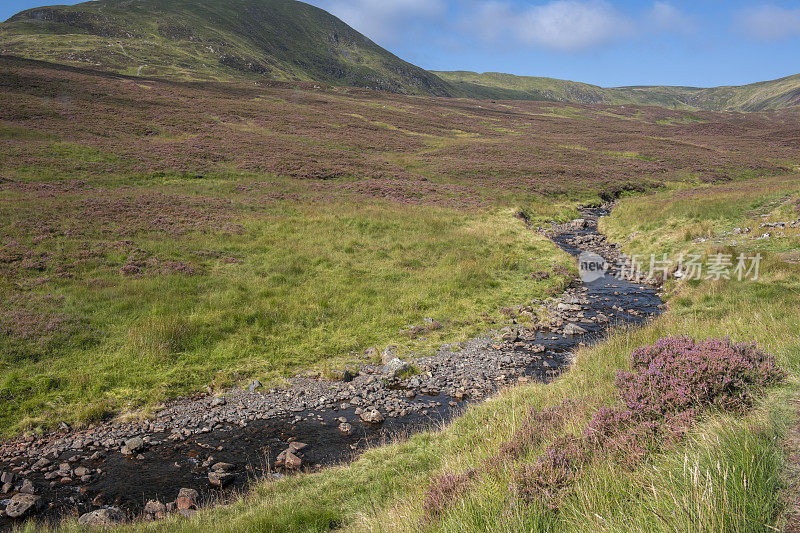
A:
[465,0,692,52]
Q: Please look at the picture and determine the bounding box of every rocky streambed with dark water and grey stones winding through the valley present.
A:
[0,209,661,529]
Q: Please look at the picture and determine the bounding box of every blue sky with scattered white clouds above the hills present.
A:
[0,0,800,87]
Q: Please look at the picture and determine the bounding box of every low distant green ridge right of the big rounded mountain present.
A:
[434,71,800,111]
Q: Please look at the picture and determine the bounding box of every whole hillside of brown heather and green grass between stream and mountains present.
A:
[0,54,800,433]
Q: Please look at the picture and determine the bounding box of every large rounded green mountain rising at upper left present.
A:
[0,0,450,96]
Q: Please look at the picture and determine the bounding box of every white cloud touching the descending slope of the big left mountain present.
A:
[316,0,447,43]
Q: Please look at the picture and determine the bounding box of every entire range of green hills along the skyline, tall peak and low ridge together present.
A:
[0,0,800,111]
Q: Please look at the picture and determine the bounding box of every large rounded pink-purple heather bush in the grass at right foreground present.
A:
[616,337,785,417]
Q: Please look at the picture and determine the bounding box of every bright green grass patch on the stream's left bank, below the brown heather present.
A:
[0,194,568,432]
